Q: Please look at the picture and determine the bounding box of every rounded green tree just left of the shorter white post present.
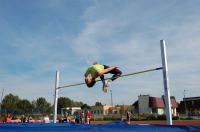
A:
[36,97,51,114]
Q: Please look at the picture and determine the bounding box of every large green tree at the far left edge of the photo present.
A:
[2,93,20,113]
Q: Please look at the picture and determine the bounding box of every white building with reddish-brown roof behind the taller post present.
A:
[133,95,178,116]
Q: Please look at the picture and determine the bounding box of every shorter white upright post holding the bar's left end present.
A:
[53,71,59,123]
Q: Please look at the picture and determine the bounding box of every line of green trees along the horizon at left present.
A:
[0,93,94,115]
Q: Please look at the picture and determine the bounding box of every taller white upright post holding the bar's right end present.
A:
[160,40,172,125]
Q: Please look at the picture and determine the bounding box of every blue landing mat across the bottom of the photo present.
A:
[0,122,200,132]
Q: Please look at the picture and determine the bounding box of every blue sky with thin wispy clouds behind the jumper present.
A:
[0,0,200,105]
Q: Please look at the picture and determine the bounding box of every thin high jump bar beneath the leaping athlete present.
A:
[57,67,162,89]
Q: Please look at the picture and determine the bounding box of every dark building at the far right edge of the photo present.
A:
[178,96,200,116]
